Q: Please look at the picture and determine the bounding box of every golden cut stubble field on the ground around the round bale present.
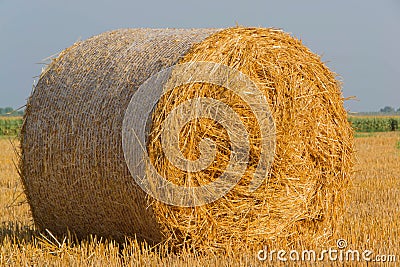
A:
[0,133,400,266]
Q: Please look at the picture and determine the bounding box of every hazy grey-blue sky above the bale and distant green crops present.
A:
[0,0,400,112]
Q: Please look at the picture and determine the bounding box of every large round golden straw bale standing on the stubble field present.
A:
[21,27,353,249]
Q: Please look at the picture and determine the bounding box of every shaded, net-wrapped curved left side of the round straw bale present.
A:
[21,29,220,242]
